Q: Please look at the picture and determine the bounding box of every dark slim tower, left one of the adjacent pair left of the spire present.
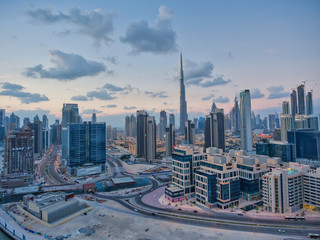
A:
[137,110,148,157]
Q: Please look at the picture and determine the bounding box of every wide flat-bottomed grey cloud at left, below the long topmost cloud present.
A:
[23,50,106,81]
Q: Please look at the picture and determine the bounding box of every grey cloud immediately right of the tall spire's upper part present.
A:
[184,59,231,88]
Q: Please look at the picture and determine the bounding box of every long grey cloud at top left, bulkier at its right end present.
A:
[25,7,115,46]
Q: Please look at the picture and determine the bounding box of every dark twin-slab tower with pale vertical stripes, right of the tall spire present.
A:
[204,108,225,151]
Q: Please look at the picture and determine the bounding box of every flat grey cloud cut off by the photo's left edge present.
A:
[0,82,49,104]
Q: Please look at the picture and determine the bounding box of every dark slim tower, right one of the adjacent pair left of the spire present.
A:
[145,117,157,162]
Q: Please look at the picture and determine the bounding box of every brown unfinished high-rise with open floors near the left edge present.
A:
[6,128,34,174]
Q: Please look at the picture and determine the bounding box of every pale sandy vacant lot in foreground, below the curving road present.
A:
[3,201,302,240]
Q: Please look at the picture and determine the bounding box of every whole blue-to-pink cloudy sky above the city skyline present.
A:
[0,0,320,128]
